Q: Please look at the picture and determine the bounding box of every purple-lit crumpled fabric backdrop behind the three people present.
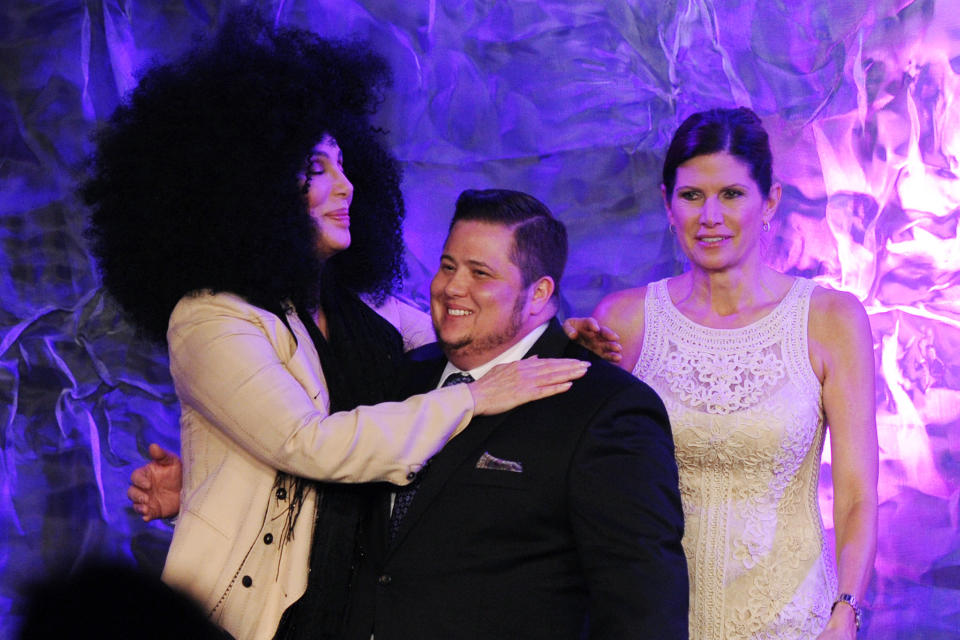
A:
[0,0,960,639]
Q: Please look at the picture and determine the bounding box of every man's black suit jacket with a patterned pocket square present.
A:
[361,320,688,640]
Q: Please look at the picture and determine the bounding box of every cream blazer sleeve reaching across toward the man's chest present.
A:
[167,294,473,484]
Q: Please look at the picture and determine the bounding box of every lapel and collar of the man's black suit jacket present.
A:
[387,318,568,558]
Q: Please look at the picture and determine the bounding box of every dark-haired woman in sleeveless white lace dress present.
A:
[568,108,877,640]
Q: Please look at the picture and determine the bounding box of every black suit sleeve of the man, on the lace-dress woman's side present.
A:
[569,384,689,640]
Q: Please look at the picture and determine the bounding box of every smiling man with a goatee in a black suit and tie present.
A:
[355,190,688,640]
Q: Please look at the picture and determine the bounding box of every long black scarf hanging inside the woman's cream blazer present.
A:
[274,269,403,640]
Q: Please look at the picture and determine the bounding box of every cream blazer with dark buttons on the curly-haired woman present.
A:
[163,293,474,640]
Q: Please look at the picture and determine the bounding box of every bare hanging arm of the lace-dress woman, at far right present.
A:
[810,289,878,640]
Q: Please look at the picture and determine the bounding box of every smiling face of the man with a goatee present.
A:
[430,220,540,370]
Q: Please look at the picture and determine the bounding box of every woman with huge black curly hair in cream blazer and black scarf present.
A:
[81,9,583,639]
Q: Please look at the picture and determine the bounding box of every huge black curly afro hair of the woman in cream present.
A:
[80,9,403,341]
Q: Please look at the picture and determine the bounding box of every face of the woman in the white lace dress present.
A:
[664,152,780,272]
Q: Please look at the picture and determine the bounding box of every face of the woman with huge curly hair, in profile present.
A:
[302,136,353,259]
